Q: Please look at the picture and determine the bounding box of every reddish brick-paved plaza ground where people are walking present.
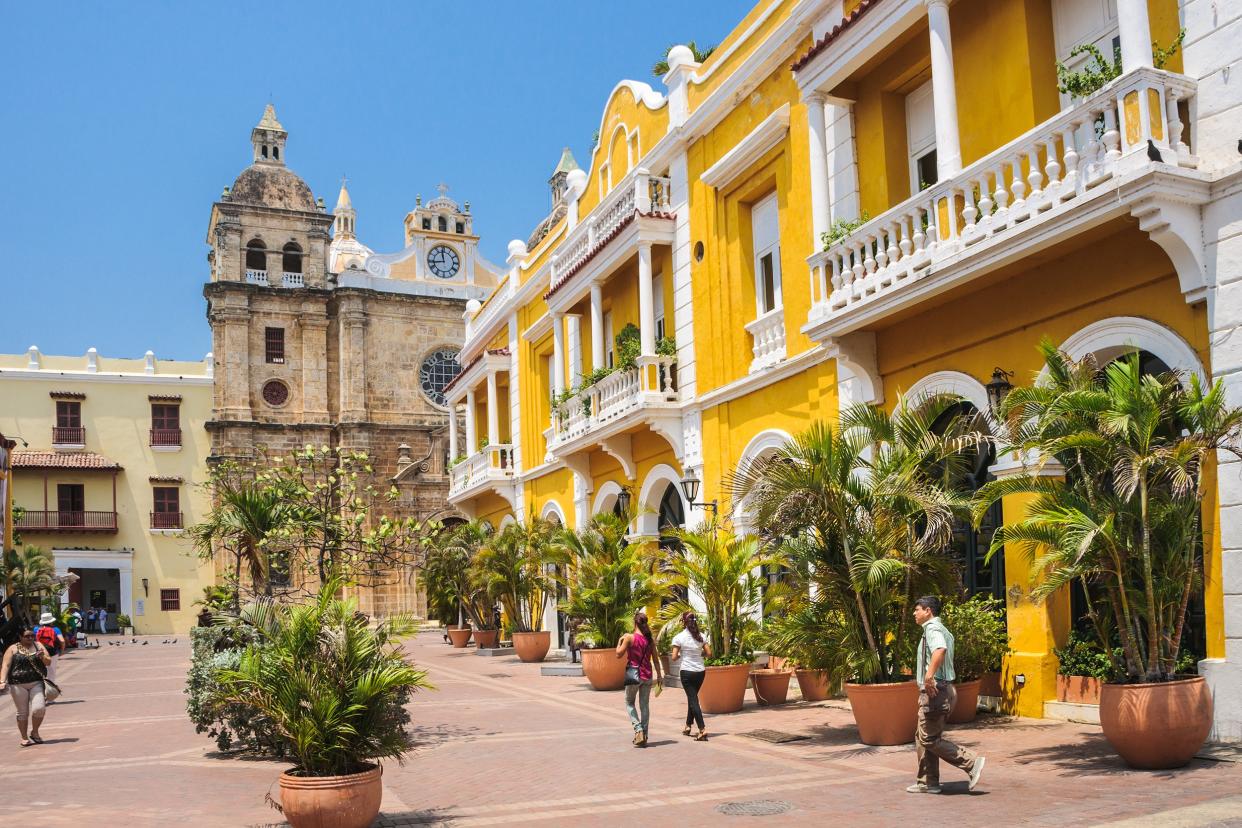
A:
[0,633,1242,827]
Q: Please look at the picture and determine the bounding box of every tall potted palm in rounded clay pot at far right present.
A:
[975,340,1242,767]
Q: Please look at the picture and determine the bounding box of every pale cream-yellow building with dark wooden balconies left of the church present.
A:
[0,346,214,634]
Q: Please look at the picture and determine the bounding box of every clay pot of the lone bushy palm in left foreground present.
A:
[281,765,384,828]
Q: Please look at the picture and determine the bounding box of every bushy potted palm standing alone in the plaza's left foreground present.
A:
[220,578,431,828]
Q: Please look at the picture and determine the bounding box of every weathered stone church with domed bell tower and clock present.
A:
[204,106,499,614]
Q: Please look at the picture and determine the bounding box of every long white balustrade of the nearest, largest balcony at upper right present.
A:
[804,70,1195,327]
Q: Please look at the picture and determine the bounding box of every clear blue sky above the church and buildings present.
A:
[0,0,751,359]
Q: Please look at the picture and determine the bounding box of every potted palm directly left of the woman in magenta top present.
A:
[559,513,669,690]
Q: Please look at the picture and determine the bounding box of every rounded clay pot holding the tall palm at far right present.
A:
[1099,675,1212,770]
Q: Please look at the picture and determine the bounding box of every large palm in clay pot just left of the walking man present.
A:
[730,395,980,745]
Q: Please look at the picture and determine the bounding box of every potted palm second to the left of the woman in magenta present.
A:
[474,515,564,662]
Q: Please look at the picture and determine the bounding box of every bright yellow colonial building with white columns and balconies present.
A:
[448,0,1242,739]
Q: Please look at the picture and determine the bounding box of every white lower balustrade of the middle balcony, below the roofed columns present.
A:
[549,356,677,451]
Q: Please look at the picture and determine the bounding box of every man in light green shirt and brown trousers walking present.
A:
[905,596,984,793]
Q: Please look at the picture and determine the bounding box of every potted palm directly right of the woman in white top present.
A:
[658,520,784,713]
